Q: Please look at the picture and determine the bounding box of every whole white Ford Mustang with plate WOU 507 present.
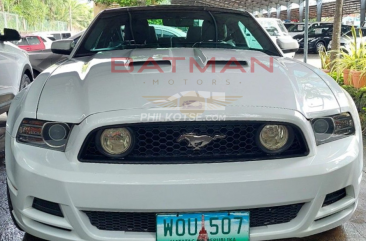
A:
[6,5,362,241]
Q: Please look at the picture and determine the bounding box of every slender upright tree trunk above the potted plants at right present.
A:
[330,0,343,70]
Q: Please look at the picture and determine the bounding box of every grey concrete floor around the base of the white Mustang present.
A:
[0,91,366,241]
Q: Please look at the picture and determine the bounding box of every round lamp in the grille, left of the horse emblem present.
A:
[96,128,134,157]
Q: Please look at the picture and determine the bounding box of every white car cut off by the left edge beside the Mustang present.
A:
[0,29,33,114]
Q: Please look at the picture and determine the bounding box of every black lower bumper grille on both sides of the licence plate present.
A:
[84,203,304,232]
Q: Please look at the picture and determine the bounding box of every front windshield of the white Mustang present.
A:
[75,10,280,57]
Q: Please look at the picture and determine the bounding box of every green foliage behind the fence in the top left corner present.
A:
[2,0,93,30]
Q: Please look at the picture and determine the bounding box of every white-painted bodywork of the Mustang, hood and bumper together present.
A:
[5,6,363,241]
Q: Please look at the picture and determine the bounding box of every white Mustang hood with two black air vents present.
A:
[37,48,340,123]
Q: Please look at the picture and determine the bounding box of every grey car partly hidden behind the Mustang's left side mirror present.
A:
[28,32,84,77]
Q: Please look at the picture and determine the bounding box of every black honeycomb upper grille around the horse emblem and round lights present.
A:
[79,121,308,164]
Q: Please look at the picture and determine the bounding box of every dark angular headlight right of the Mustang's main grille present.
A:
[311,113,355,145]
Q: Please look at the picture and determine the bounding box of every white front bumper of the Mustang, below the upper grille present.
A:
[6,130,362,241]
